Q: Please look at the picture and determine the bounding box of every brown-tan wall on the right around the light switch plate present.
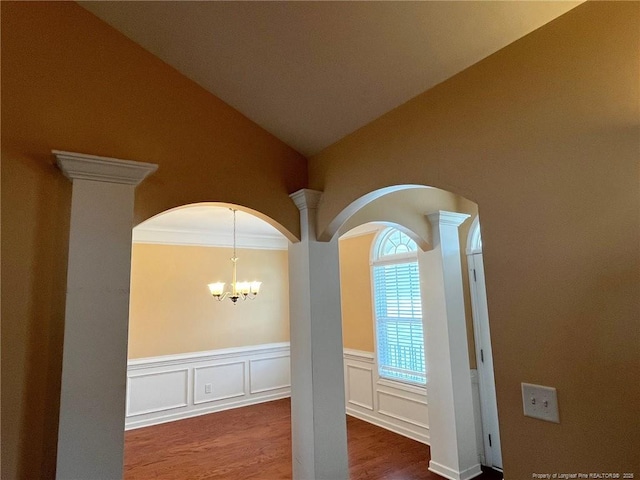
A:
[310,2,640,479]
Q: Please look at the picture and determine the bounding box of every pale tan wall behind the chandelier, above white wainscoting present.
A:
[129,244,289,358]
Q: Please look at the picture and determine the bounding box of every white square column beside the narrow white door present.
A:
[418,211,482,480]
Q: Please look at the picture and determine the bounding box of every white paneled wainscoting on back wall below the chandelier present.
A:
[125,343,291,430]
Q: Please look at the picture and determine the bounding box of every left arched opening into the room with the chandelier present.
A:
[125,203,291,478]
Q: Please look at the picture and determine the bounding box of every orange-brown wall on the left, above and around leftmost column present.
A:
[1,2,307,479]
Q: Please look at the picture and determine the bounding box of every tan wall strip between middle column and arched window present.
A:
[339,233,375,352]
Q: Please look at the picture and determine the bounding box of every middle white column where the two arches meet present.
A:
[289,190,349,480]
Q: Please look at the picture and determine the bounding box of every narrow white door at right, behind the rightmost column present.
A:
[467,253,502,469]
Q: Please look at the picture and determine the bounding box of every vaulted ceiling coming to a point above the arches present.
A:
[80,0,581,155]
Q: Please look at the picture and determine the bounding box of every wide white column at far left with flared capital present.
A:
[53,151,157,480]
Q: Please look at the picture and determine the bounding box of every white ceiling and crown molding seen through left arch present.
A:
[133,205,289,250]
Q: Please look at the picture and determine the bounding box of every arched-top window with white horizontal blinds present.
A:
[373,228,426,384]
